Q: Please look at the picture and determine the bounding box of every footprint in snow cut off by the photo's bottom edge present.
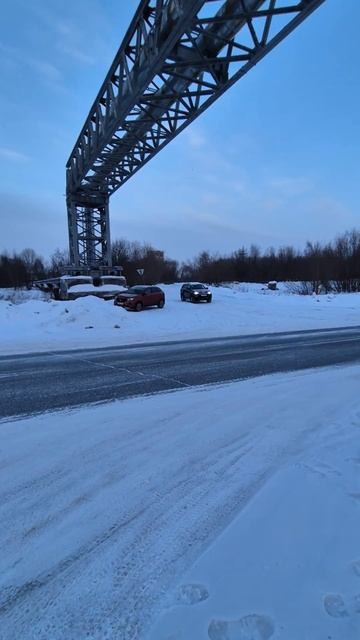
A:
[208,613,275,640]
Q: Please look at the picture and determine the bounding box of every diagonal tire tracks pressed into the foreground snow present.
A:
[2,390,316,640]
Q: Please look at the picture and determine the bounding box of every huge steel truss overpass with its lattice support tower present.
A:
[66,0,324,267]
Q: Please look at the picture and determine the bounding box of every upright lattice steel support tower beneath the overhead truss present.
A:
[68,199,111,267]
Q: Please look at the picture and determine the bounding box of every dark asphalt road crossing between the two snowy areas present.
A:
[0,326,360,418]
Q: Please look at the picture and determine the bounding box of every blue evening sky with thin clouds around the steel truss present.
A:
[0,0,360,260]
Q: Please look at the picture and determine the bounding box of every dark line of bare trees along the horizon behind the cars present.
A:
[0,229,360,293]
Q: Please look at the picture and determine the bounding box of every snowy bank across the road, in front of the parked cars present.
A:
[0,284,360,354]
